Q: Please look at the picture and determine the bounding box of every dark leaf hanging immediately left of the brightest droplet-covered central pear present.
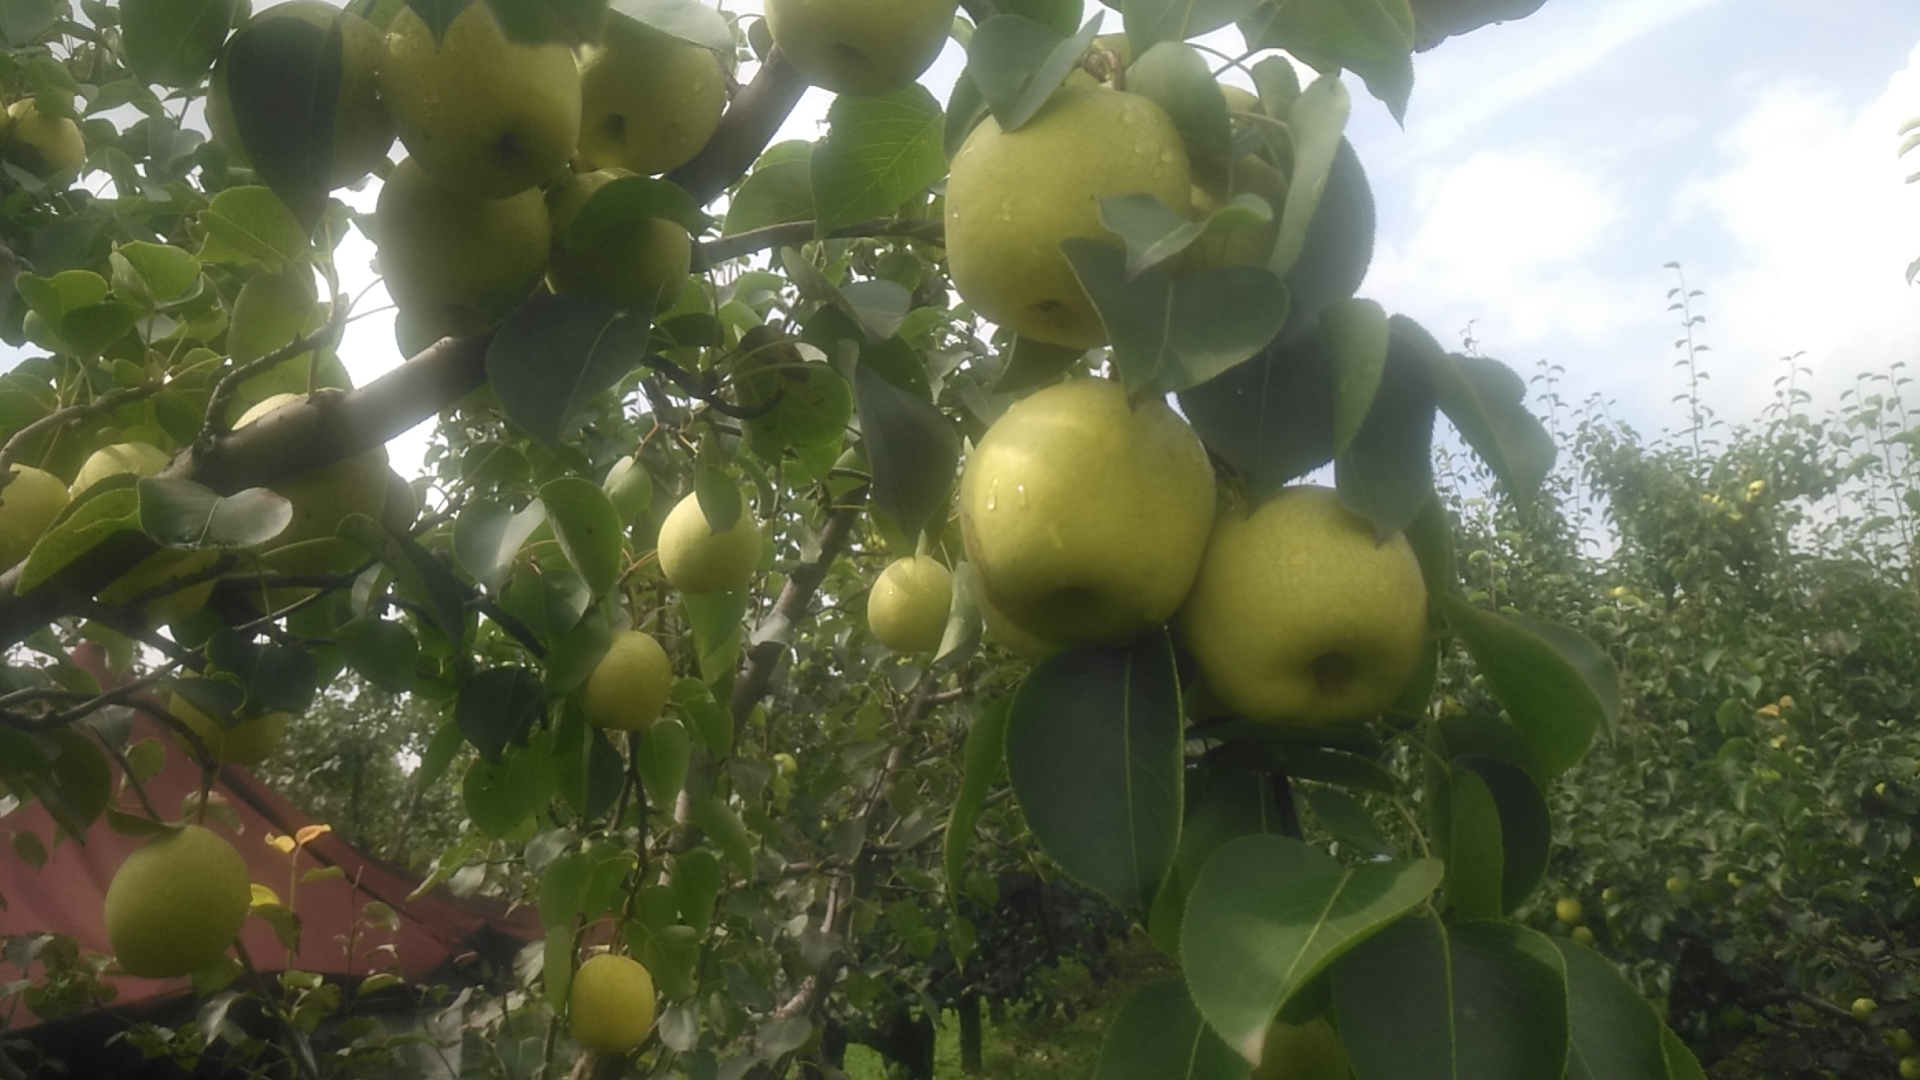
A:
[852,363,960,536]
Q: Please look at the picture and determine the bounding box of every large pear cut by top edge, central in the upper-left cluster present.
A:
[380,4,580,198]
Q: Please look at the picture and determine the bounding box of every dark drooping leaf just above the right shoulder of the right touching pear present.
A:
[1334,334,1434,540]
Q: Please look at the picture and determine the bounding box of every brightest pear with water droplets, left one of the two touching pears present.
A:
[960,378,1213,648]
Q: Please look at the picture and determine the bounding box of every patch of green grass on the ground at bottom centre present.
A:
[847,938,1175,1080]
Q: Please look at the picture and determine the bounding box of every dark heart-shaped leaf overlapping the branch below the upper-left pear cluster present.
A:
[486,296,653,446]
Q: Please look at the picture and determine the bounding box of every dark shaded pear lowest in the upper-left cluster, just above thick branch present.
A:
[374,154,553,342]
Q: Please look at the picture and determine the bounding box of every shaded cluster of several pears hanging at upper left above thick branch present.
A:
[204,0,730,343]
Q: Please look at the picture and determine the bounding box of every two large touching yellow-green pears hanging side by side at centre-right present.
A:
[960,379,1427,724]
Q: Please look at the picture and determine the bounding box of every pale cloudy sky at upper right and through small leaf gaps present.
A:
[33,0,1920,471]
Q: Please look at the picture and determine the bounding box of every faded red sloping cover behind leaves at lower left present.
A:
[0,646,541,1028]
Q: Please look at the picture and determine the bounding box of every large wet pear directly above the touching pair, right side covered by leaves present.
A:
[947,86,1192,348]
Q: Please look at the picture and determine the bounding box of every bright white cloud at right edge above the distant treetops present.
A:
[1672,46,1920,419]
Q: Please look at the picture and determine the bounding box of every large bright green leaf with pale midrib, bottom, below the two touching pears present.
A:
[1181,836,1443,1053]
